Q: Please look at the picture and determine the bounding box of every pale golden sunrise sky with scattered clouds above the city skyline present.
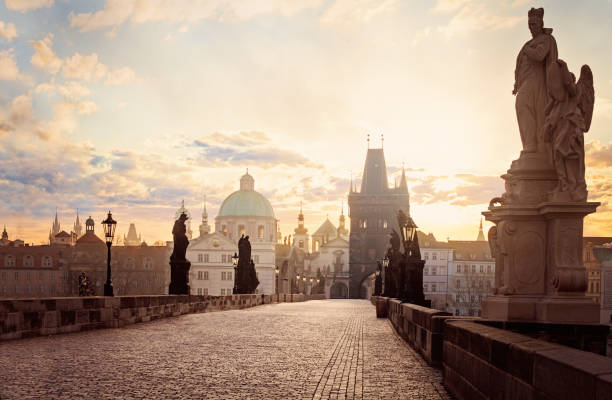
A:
[0,0,612,244]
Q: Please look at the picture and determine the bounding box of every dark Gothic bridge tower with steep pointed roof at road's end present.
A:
[348,138,410,298]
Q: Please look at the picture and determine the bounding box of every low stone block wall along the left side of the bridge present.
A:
[0,294,325,341]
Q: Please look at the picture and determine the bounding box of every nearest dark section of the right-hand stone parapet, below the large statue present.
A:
[443,320,612,400]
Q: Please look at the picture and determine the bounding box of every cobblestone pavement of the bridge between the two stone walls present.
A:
[0,300,449,400]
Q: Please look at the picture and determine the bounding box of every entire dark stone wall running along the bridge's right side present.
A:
[372,297,612,400]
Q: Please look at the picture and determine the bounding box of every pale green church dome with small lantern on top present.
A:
[218,173,274,218]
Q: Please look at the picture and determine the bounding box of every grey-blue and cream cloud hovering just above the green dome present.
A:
[192,132,320,168]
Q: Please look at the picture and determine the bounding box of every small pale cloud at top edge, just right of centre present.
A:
[320,0,400,24]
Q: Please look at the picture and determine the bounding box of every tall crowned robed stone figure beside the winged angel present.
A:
[512,8,557,153]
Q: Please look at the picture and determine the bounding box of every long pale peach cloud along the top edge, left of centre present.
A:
[68,0,326,32]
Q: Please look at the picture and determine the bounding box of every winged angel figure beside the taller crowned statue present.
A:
[544,59,595,202]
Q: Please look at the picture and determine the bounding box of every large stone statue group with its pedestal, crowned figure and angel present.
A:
[482,8,599,323]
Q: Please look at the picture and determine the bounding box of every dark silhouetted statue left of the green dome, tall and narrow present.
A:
[168,213,191,294]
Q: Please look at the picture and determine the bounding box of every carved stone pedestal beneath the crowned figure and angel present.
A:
[482,153,599,323]
